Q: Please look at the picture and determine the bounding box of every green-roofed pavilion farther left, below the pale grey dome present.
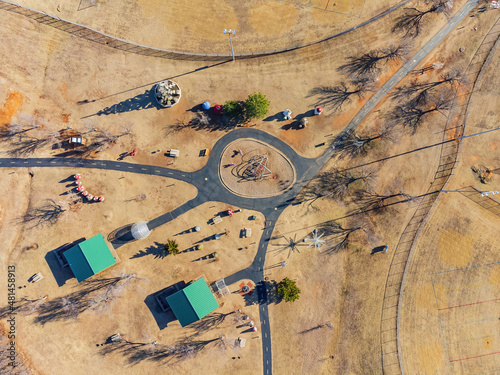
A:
[63,233,116,282]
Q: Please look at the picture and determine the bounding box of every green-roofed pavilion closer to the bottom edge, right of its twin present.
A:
[166,278,219,327]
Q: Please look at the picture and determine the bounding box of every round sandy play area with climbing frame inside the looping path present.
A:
[219,138,295,198]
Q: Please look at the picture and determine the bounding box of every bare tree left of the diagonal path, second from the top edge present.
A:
[337,43,409,77]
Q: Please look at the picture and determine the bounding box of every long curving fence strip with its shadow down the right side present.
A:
[380,13,500,375]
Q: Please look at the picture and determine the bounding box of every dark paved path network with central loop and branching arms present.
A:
[0,0,478,375]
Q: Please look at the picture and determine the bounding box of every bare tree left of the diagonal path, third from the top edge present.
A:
[308,80,373,113]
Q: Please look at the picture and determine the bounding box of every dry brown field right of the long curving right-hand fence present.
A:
[401,41,500,374]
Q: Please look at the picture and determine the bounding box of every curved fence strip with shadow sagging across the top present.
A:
[0,0,410,61]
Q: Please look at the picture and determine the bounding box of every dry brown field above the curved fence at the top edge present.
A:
[13,0,399,54]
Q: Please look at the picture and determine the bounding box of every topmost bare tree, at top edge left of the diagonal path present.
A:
[392,0,453,38]
